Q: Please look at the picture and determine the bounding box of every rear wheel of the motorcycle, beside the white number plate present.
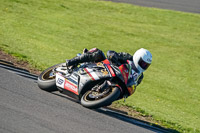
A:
[37,63,64,92]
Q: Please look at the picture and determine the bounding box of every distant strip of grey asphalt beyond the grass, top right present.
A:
[106,0,200,13]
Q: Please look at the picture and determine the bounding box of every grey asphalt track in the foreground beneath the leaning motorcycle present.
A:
[0,64,175,133]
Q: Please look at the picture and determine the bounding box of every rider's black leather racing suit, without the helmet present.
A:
[66,48,143,86]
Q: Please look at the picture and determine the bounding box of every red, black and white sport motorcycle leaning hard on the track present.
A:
[38,59,133,108]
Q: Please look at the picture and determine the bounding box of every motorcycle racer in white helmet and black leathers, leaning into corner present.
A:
[66,48,152,95]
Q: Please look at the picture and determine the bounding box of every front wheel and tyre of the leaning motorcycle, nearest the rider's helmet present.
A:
[81,87,120,109]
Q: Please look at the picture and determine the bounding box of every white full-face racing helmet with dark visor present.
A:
[133,48,152,72]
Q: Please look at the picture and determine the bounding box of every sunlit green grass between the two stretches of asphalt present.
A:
[0,0,200,132]
